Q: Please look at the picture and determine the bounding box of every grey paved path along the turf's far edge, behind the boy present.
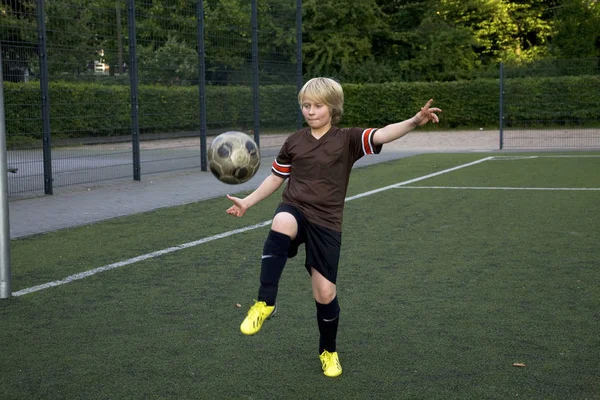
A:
[9,131,498,239]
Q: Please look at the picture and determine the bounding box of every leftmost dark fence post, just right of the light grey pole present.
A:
[37,0,54,194]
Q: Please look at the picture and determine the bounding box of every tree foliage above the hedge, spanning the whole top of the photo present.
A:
[0,0,600,83]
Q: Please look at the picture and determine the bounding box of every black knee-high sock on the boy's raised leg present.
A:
[258,230,291,306]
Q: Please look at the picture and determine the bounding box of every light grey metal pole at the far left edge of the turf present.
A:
[0,46,12,299]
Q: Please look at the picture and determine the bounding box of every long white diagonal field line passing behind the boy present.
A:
[12,157,494,297]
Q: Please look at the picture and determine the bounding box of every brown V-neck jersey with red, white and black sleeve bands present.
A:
[271,126,382,232]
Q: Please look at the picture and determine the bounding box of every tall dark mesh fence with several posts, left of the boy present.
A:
[0,0,301,195]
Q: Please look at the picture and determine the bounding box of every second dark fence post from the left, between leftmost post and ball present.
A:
[127,0,142,181]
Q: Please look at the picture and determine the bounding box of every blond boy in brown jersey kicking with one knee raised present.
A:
[227,78,442,377]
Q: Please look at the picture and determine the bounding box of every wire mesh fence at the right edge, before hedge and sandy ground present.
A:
[500,58,600,149]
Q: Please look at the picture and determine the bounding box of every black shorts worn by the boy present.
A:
[275,203,342,284]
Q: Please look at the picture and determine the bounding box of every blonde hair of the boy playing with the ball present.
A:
[298,78,344,125]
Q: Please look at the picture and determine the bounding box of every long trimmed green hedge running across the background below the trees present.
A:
[4,76,600,144]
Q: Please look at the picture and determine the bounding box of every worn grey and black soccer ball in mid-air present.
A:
[208,131,260,185]
